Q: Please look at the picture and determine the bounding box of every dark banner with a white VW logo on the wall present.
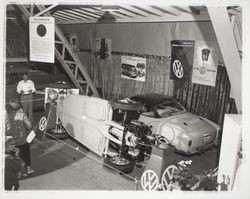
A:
[170,40,195,81]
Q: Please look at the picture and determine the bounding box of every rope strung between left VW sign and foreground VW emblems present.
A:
[43,131,138,183]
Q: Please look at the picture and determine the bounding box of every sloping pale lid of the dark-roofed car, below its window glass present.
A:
[167,113,217,133]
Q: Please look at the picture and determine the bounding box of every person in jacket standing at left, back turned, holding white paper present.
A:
[8,99,34,176]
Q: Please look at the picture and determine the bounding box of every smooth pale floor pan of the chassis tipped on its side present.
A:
[60,95,110,155]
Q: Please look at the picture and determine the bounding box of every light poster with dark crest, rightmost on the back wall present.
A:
[192,41,219,86]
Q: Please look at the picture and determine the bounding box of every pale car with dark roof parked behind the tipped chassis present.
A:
[129,94,220,155]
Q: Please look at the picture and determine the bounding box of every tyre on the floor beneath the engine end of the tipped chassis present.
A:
[104,156,134,174]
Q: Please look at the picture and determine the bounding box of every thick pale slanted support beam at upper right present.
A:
[207,7,242,112]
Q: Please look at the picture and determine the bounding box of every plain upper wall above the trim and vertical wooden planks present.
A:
[60,22,222,61]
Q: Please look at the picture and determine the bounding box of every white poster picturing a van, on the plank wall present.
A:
[121,56,146,81]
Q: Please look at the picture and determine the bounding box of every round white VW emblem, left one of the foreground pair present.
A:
[141,170,159,191]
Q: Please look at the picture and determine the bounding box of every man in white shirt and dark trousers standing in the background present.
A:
[17,73,36,122]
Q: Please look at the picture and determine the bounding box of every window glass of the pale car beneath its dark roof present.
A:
[142,100,185,118]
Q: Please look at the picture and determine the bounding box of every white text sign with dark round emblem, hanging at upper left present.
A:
[29,17,55,63]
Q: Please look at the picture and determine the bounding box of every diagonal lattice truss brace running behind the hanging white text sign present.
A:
[17,4,99,97]
